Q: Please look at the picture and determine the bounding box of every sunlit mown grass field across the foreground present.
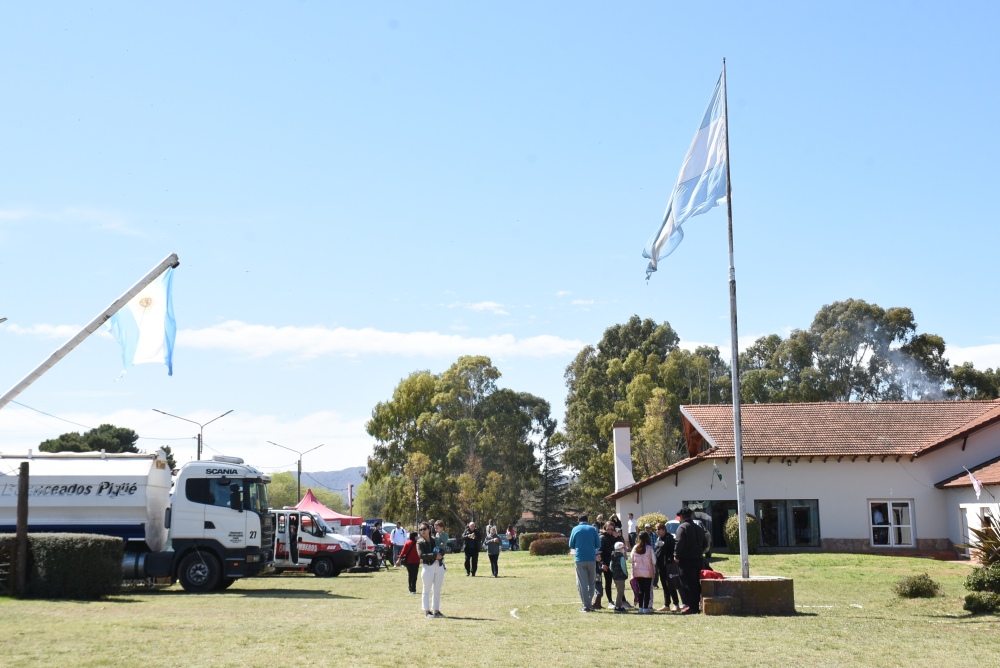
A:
[0,552,1000,668]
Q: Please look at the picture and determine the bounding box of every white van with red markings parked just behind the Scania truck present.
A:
[271,509,359,578]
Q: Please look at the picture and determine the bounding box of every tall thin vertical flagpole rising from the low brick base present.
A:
[722,58,750,578]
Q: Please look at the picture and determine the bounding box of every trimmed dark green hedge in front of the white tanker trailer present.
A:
[0,533,125,600]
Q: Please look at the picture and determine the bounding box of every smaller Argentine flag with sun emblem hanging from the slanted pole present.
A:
[108,267,177,376]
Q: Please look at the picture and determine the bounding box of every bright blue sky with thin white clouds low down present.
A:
[0,2,1000,470]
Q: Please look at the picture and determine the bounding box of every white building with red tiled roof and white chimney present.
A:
[608,401,1000,554]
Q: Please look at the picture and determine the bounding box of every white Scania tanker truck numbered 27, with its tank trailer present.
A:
[0,451,274,592]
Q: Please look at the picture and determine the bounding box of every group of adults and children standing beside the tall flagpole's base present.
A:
[569,508,708,614]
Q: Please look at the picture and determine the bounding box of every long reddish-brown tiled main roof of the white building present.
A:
[681,401,1000,457]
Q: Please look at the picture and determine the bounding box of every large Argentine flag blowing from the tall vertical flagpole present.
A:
[642,76,727,280]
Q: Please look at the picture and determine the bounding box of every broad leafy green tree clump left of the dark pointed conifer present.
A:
[366,356,555,524]
